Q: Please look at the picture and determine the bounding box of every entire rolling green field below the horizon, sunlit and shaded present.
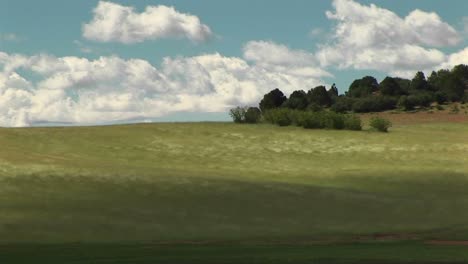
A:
[0,123,468,263]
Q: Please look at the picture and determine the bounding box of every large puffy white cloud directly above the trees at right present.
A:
[317,0,461,75]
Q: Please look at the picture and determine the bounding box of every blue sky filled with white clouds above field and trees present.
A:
[0,0,468,127]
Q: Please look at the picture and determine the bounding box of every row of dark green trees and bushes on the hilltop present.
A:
[230,64,468,125]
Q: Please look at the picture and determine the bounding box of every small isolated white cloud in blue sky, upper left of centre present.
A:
[83,1,212,44]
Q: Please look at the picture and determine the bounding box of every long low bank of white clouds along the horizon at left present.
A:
[0,42,330,126]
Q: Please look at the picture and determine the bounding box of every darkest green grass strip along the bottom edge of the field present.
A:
[0,242,468,264]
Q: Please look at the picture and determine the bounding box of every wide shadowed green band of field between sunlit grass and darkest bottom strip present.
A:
[0,172,468,243]
